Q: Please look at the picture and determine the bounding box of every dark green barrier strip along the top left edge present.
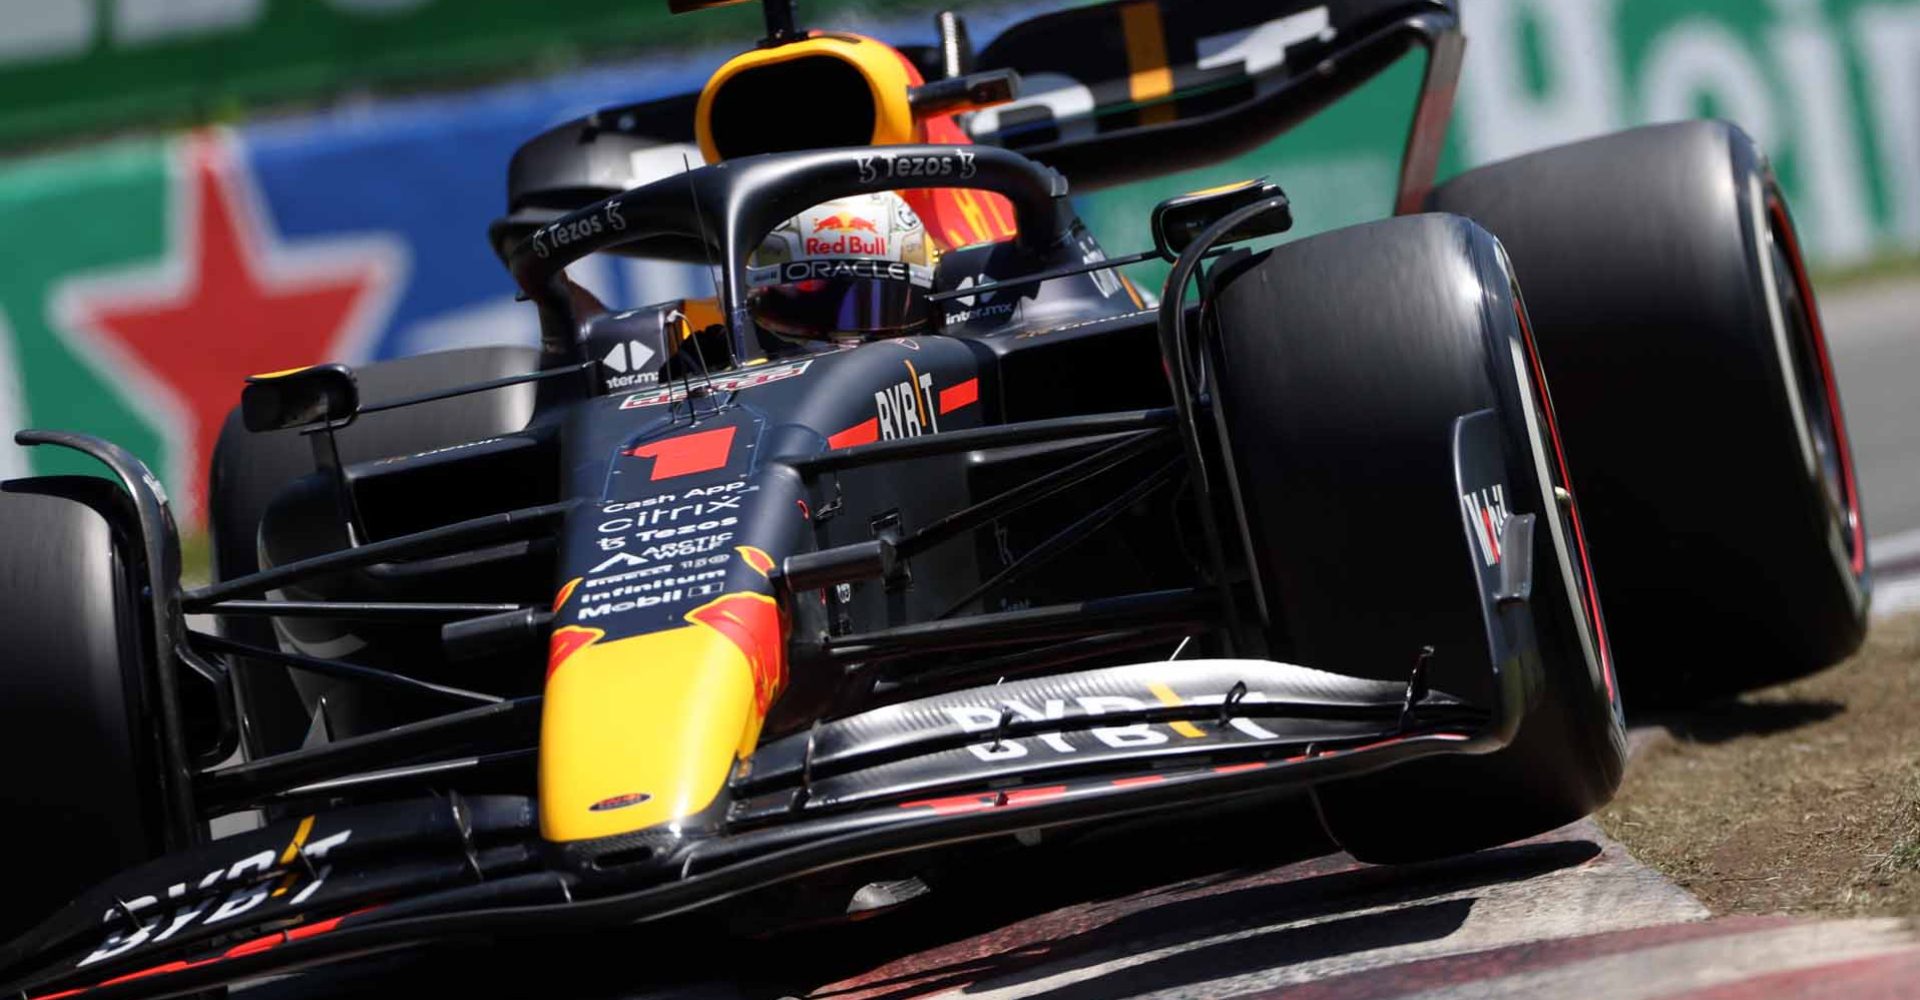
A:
[0,0,964,144]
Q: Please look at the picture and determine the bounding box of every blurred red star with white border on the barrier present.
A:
[69,136,392,524]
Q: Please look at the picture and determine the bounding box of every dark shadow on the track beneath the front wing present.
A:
[240,810,1601,1000]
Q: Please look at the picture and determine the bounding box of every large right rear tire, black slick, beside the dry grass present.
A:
[1430,121,1870,706]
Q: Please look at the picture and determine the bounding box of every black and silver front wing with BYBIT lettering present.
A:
[0,568,1534,998]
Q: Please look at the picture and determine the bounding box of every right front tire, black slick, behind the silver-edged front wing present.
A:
[1210,215,1624,862]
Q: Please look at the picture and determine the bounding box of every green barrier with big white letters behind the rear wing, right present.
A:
[1083,0,1920,267]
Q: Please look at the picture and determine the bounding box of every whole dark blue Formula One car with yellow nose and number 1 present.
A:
[0,0,1868,996]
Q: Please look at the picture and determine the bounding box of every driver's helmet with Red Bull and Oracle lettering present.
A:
[747,192,933,340]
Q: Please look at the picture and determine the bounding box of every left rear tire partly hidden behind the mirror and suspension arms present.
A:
[207,347,540,756]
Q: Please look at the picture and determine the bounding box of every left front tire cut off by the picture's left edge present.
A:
[0,476,161,940]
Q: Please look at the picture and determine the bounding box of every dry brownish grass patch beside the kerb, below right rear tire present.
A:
[1597,602,1920,917]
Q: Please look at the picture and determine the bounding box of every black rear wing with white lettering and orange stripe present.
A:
[495,0,1465,226]
